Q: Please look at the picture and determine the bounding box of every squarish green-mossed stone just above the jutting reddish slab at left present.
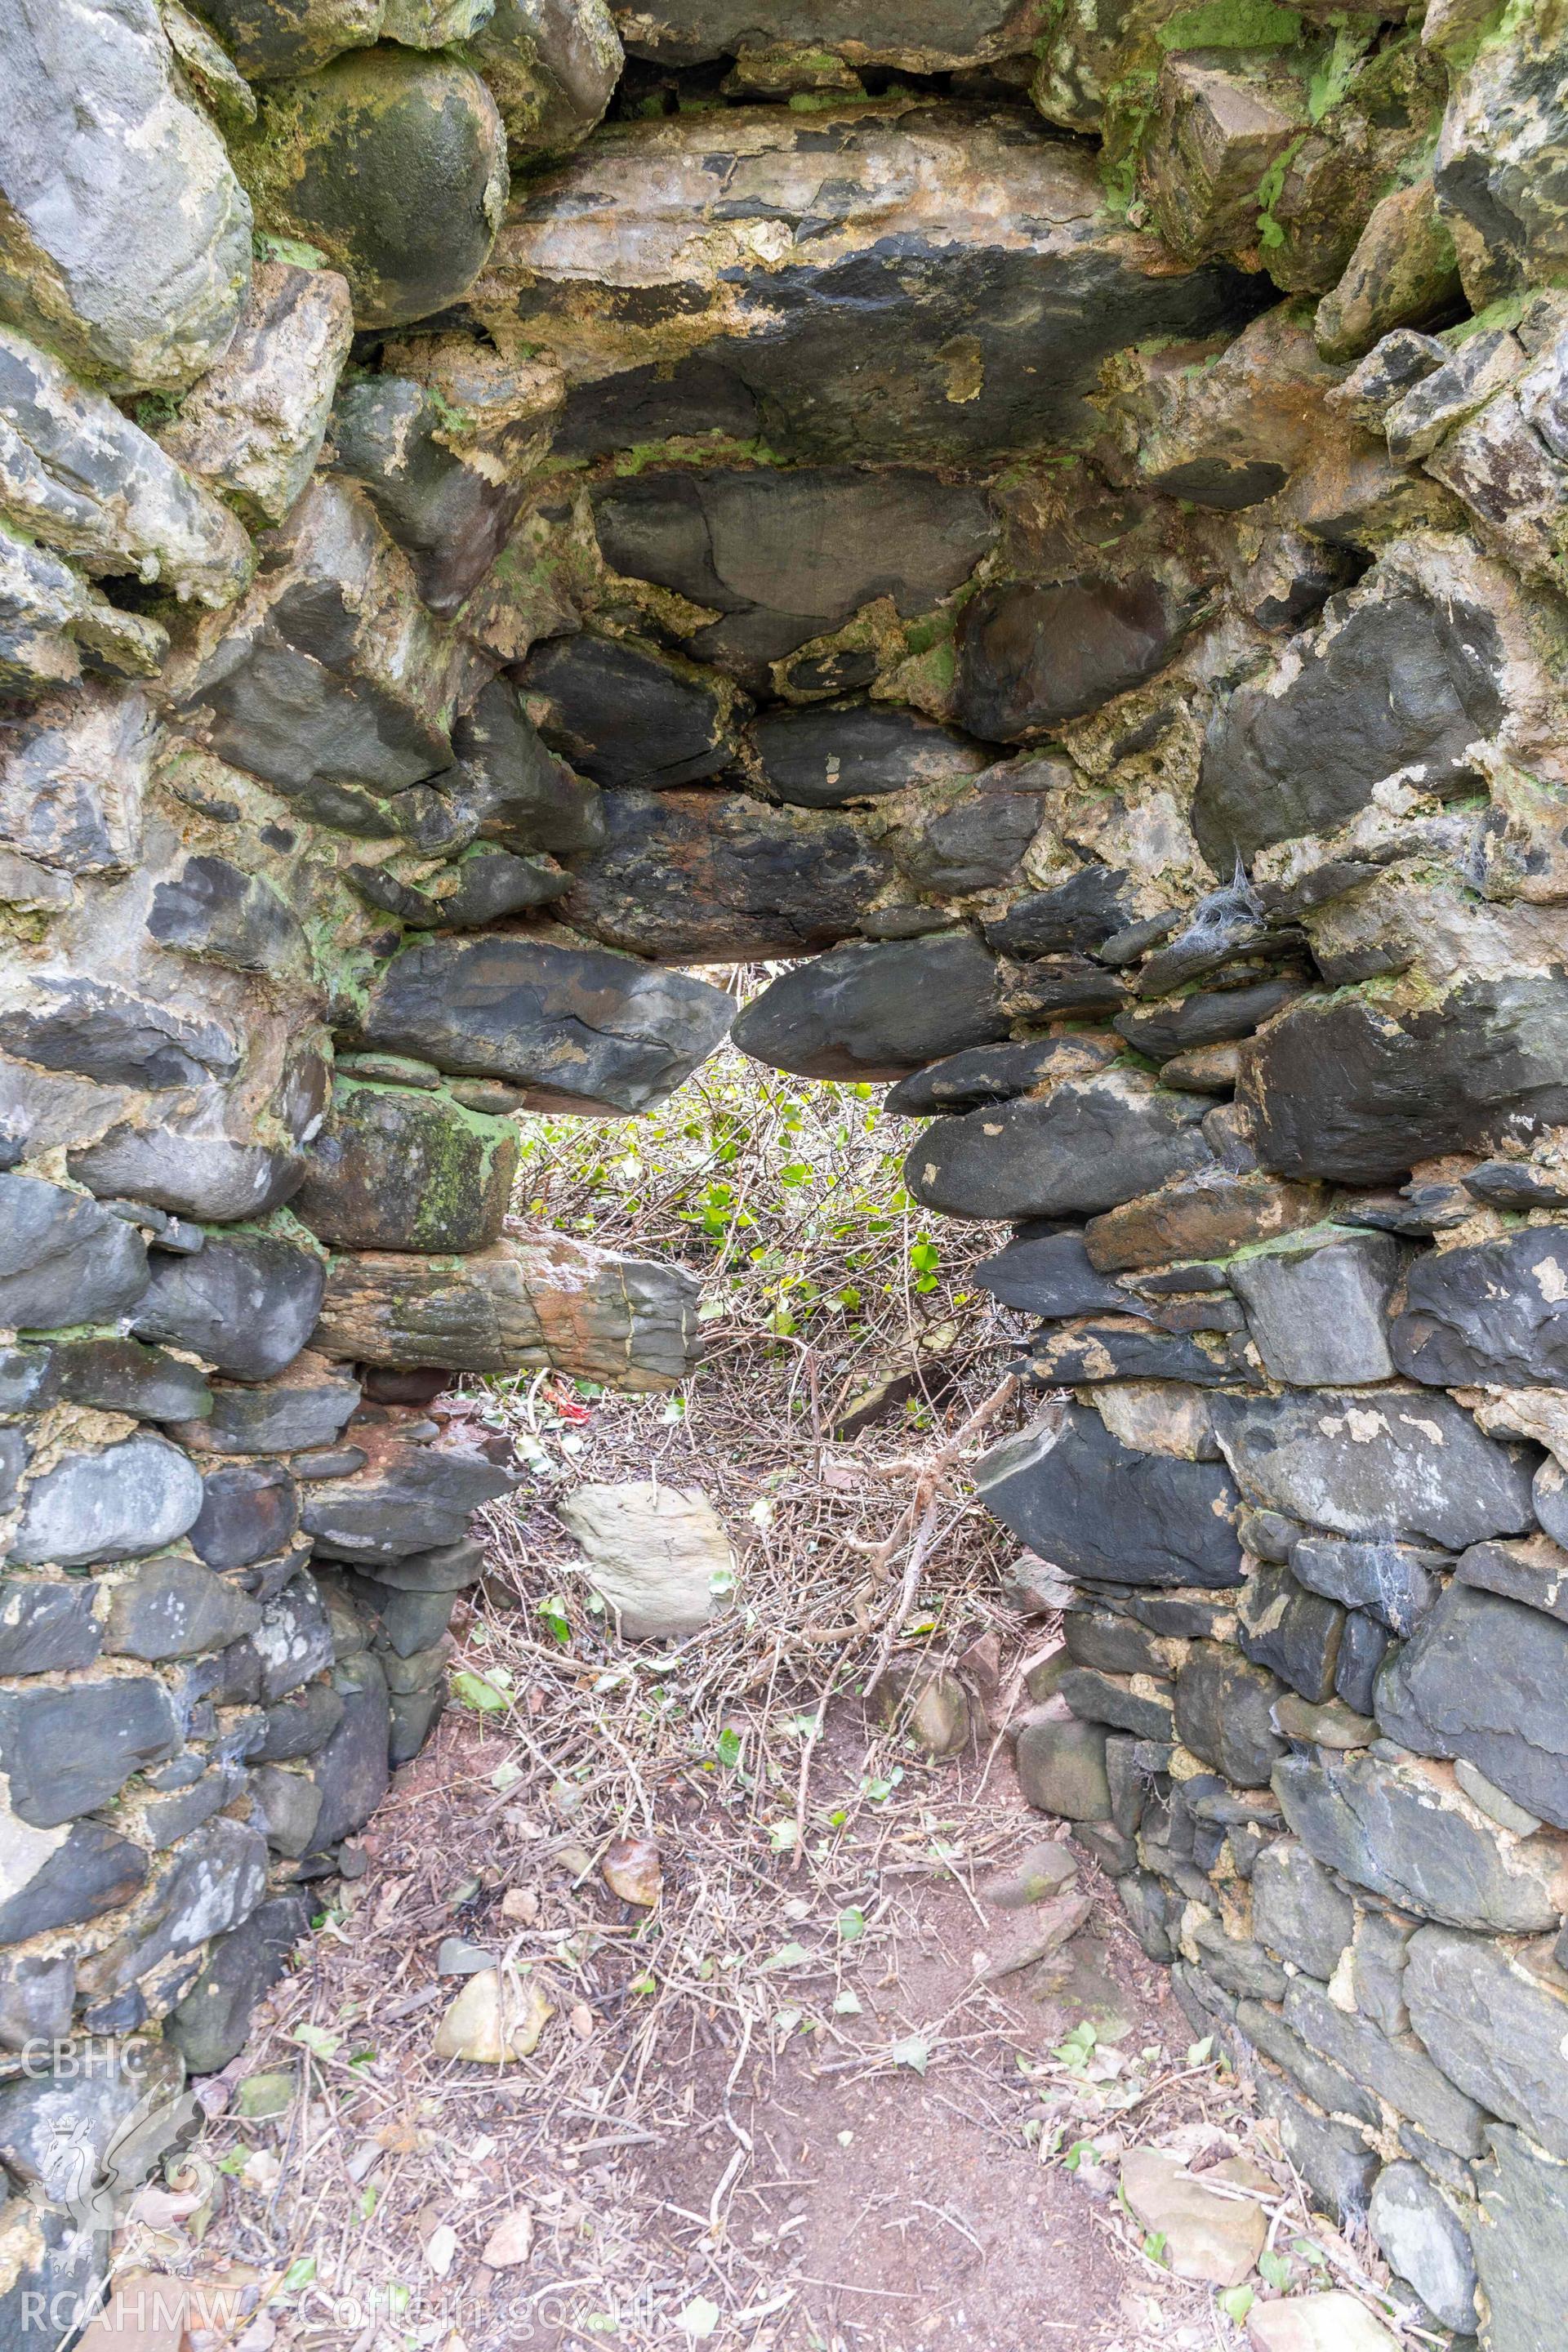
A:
[294,1080,517,1251]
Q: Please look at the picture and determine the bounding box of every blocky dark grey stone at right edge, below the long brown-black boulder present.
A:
[1392,1225,1568,1388]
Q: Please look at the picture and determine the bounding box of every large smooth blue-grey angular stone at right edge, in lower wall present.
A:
[1378,1583,1568,1830]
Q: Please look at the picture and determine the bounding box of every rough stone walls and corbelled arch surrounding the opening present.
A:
[0,0,1568,2352]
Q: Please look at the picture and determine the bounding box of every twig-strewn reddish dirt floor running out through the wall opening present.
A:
[91,1056,1415,2352]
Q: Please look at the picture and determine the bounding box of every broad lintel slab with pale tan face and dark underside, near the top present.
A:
[477,106,1255,463]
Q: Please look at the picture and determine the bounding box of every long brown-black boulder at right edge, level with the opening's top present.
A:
[1241,976,1568,1185]
